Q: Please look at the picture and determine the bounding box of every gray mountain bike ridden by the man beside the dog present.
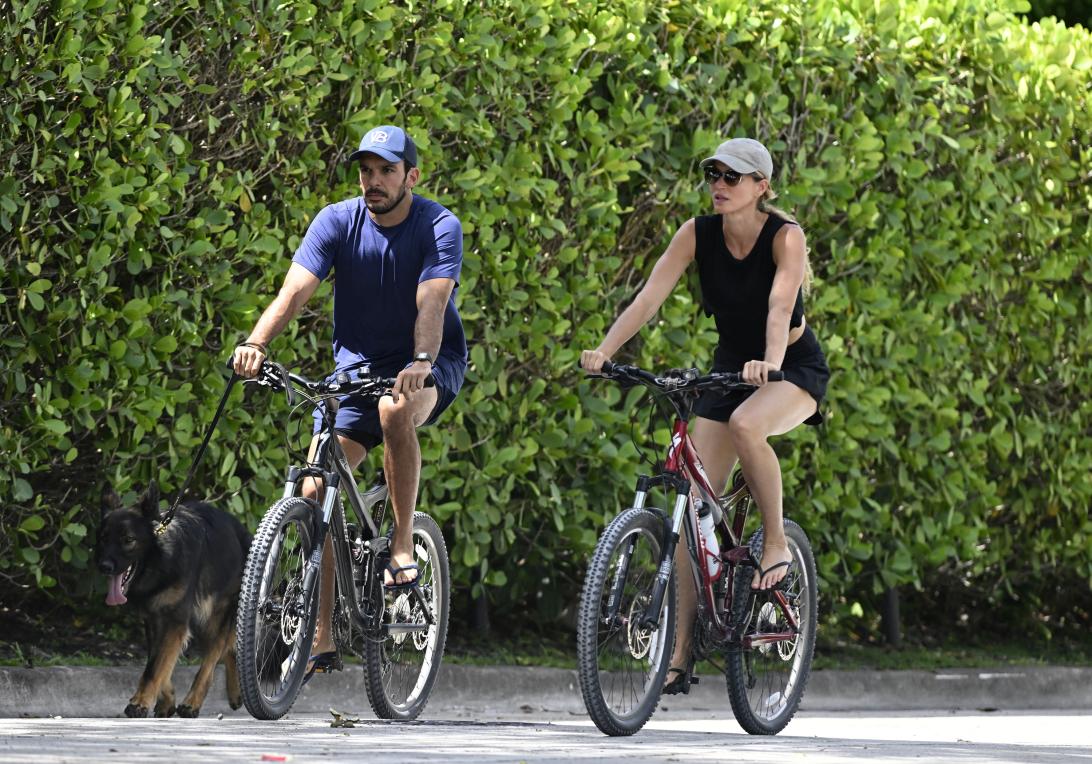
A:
[236,360,450,720]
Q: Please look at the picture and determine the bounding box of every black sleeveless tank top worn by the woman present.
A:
[695,215,804,365]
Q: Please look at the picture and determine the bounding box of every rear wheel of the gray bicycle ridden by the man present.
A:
[364,512,451,721]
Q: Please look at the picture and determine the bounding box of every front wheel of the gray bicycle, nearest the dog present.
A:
[236,497,319,719]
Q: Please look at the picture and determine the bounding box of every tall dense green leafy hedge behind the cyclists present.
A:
[0,0,1092,626]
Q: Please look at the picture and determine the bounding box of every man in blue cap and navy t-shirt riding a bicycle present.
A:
[234,126,466,677]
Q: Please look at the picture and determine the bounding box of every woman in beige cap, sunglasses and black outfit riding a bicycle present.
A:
[580,138,830,694]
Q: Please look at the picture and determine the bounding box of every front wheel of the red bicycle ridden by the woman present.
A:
[577,509,676,736]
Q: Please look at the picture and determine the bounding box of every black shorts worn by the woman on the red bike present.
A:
[693,326,830,425]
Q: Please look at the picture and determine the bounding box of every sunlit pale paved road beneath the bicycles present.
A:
[0,707,1092,764]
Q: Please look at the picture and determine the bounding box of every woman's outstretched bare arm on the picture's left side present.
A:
[580,218,697,373]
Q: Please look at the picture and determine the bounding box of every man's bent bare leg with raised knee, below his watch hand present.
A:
[379,387,438,584]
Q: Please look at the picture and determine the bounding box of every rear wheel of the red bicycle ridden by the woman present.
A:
[726,520,818,735]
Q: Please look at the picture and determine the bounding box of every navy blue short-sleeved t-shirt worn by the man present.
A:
[292,195,466,392]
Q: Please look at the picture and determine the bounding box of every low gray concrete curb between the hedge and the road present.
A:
[0,665,1092,719]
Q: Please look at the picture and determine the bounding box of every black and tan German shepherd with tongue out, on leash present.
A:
[95,482,250,718]
